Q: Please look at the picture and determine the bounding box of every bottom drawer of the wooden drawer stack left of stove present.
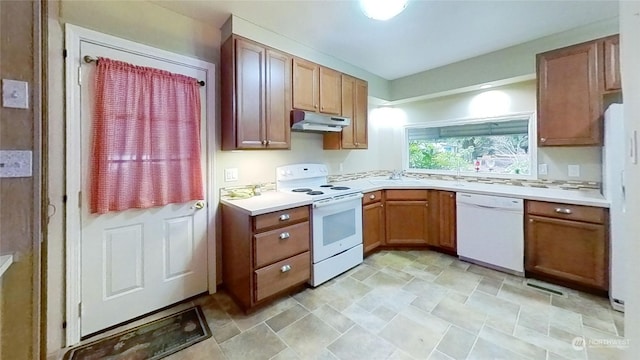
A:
[255,251,311,301]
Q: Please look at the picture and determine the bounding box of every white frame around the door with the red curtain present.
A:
[64,24,217,346]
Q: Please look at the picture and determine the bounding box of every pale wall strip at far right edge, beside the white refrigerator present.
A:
[620,1,640,360]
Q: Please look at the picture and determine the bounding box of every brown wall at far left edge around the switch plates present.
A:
[0,1,42,360]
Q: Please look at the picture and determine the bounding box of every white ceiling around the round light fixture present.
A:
[153,0,618,80]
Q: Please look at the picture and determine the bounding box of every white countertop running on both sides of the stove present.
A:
[220,178,609,216]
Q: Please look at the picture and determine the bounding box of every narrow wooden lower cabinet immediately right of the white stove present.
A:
[362,191,385,254]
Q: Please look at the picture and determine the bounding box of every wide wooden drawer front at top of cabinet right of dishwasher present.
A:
[527,201,606,224]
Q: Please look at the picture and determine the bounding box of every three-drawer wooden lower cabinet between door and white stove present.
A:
[222,204,311,310]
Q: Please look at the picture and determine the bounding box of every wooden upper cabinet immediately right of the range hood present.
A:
[323,74,369,150]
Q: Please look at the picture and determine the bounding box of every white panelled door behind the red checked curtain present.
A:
[76,41,208,336]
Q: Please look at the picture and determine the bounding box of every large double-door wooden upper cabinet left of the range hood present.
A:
[220,36,291,150]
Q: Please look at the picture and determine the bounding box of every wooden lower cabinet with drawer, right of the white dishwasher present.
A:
[525,201,609,291]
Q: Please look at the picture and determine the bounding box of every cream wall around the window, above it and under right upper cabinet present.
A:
[384,80,602,182]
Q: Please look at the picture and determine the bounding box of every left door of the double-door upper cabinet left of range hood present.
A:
[235,39,266,149]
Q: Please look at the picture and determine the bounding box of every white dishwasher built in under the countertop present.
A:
[456,193,524,275]
